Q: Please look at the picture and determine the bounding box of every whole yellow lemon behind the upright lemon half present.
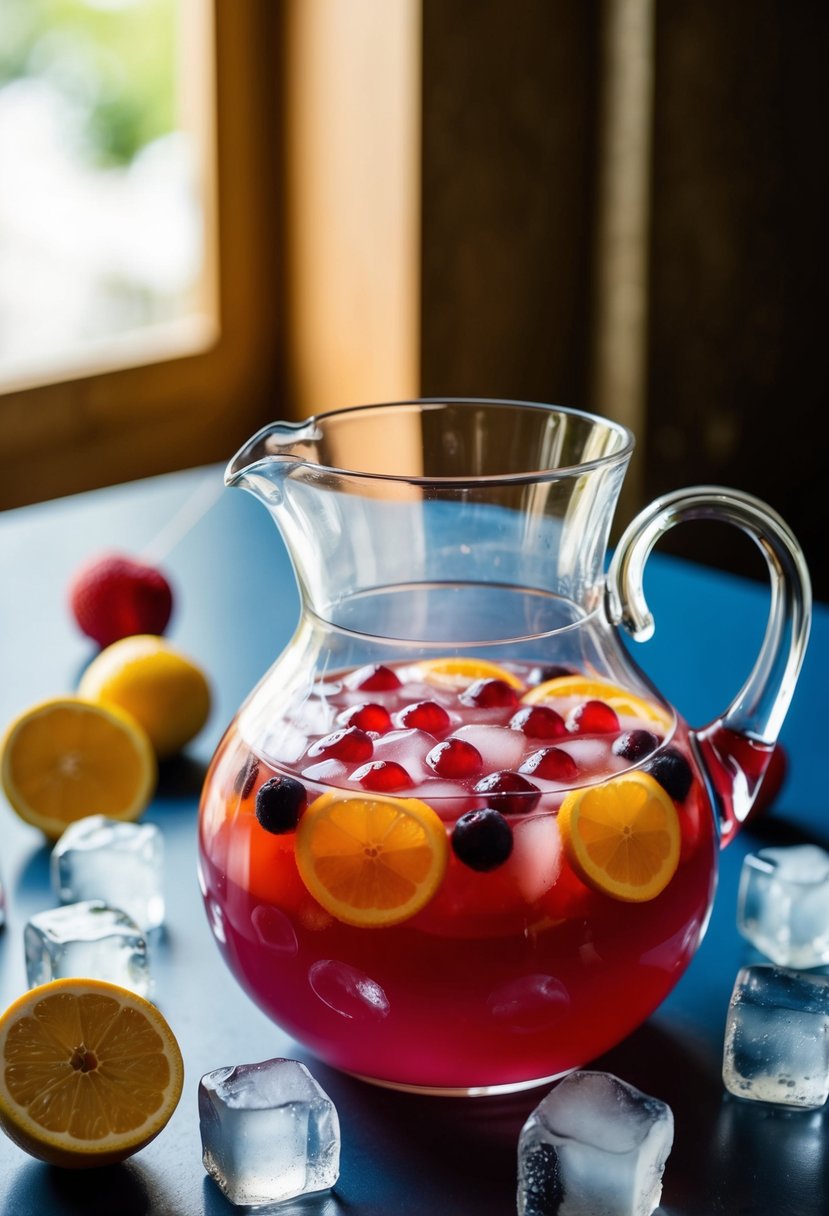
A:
[78,634,210,760]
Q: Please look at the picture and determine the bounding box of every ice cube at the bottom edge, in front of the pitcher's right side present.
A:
[518,1071,673,1216]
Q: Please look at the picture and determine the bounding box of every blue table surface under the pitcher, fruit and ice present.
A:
[0,467,829,1216]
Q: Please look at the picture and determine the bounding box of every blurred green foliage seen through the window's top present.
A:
[0,0,177,167]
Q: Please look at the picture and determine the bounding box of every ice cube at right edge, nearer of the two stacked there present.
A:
[722,963,829,1110]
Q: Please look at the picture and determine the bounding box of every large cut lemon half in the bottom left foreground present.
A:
[0,979,184,1169]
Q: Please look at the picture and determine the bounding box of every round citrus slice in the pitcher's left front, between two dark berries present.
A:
[297,790,449,928]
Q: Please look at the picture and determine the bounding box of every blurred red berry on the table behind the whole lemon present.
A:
[69,553,173,648]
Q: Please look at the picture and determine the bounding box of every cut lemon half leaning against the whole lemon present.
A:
[0,697,157,840]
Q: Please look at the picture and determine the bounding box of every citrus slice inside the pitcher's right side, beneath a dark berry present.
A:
[558,772,681,903]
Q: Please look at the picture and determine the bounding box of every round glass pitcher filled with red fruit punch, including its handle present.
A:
[199,400,811,1093]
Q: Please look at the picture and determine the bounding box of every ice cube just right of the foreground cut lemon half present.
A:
[198,1059,340,1205]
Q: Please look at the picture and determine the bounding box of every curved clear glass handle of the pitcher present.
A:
[607,485,812,844]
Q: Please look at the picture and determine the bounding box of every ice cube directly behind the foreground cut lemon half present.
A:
[23,900,151,996]
